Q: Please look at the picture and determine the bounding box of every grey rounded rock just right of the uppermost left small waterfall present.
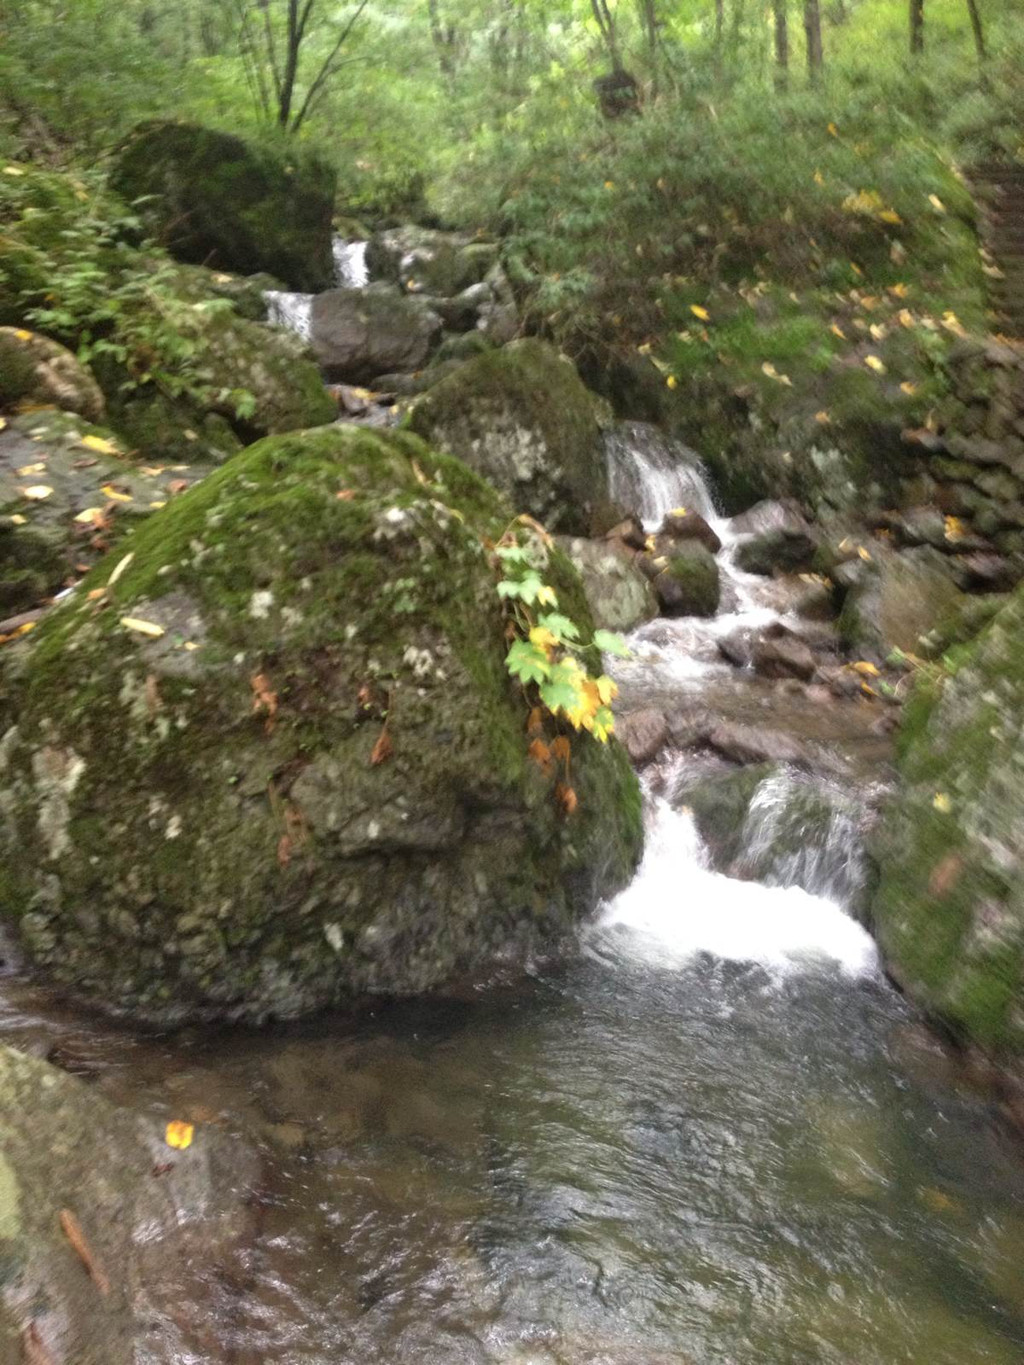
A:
[311,284,441,384]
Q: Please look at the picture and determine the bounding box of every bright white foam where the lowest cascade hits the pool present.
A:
[598,800,878,977]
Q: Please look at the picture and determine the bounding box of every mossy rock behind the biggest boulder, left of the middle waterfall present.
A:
[410,339,608,535]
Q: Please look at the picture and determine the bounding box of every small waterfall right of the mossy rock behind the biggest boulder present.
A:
[605,422,717,527]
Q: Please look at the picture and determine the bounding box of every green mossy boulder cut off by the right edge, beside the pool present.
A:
[874,592,1024,1055]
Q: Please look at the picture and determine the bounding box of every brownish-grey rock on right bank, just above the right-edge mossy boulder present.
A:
[838,546,961,658]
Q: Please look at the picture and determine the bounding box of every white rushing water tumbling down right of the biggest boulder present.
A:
[599,423,878,977]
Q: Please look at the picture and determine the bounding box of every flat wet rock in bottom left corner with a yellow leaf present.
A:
[0,1047,257,1365]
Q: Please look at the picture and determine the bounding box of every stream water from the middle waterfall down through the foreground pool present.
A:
[0,417,1024,1365]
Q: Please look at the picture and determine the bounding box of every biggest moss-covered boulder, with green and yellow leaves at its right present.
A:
[0,427,640,1018]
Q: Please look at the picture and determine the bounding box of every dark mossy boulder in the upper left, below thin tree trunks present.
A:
[111,120,335,293]
